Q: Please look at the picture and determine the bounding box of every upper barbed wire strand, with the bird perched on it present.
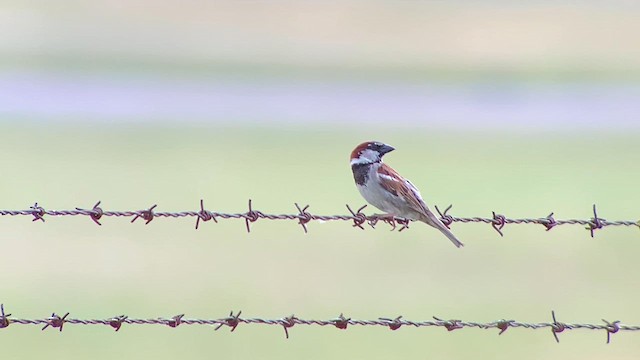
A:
[0,199,640,237]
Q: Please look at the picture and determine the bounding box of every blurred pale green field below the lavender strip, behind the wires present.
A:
[0,124,640,359]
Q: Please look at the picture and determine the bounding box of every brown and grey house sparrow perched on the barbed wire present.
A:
[351,141,464,247]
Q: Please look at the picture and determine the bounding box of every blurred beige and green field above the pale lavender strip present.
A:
[0,0,640,81]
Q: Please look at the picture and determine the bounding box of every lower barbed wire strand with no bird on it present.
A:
[0,305,640,344]
